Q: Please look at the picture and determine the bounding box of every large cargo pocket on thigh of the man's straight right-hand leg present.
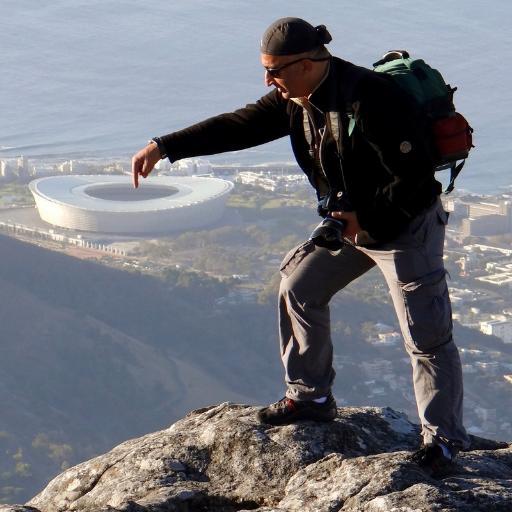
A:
[401,268,452,350]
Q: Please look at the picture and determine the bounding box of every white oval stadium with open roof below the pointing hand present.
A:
[30,175,233,234]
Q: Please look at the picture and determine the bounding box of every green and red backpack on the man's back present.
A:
[373,50,474,193]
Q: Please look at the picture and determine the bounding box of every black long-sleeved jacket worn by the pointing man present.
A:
[161,58,441,242]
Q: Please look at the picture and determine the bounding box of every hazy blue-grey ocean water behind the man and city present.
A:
[0,0,512,193]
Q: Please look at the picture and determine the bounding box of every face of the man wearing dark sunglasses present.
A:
[261,53,311,100]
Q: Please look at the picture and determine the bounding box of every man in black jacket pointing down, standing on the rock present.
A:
[133,18,468,468]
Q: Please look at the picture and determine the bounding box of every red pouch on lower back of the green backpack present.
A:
[432,112,473,164]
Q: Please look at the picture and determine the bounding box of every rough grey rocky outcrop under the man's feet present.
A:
[0,404,512,512]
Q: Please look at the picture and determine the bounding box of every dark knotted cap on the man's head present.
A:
[260,18,332,55]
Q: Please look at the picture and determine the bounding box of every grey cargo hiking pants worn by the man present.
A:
[279,200,468,447]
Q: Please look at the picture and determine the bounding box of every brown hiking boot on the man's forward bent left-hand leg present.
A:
[258,394,337,425]
